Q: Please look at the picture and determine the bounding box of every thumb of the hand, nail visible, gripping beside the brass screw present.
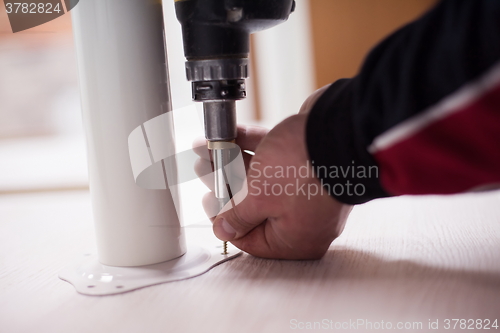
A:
[213,189,269,241]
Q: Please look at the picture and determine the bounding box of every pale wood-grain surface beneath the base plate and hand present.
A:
[0,191,500,333]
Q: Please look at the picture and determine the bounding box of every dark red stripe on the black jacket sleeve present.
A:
[373,83,500,195]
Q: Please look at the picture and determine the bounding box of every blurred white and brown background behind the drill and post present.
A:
[0,0,436,195]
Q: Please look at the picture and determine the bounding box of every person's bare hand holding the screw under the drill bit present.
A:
[191,85,351,259]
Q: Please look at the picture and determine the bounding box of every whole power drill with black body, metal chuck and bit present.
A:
[175,0,295,249]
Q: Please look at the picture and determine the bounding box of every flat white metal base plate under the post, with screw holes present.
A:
[59,243,241,296]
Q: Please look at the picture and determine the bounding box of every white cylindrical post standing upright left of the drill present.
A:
[72,0,186,266]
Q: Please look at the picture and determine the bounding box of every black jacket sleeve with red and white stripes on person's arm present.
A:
[306,0,500,204]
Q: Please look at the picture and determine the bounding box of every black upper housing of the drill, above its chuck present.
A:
[175,0,295,60]
